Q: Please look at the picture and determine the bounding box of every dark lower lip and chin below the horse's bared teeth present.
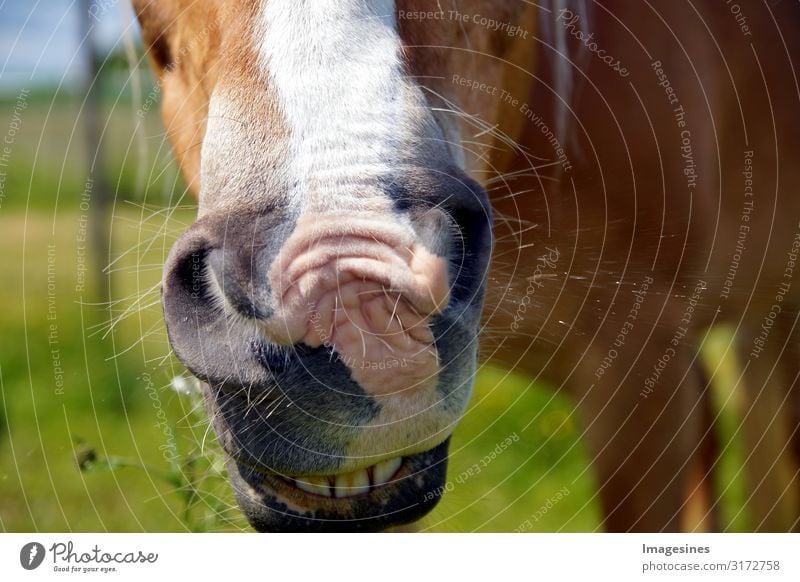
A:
[228,439,449,532]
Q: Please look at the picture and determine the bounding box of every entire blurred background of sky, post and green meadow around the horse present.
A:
[0,0,744,532]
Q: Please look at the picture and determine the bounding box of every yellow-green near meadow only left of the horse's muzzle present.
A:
[0,205,244,531]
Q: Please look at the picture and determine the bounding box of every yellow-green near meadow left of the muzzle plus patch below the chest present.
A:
[0,208,598,531]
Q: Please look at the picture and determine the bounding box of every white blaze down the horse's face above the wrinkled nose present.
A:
[259,0,412,209]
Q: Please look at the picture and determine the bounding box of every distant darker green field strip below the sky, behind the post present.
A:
[0,82,183,215]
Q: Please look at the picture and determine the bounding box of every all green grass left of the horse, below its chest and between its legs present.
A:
[0,98,743,532]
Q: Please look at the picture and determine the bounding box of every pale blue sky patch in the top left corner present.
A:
[0,0,138,94]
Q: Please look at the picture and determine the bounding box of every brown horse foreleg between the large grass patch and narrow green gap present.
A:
[580,320,703,532]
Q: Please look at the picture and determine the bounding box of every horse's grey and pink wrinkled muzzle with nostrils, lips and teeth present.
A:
[162,171,491,530]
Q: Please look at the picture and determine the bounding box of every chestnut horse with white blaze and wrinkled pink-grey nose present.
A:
[134,0,800,531]
